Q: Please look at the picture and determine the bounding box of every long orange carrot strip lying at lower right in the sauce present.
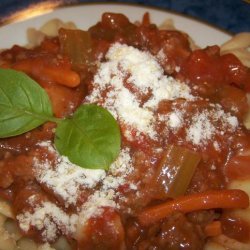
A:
[138,189,249,226]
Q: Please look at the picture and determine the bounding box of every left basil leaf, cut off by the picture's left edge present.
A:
[0,69,53,138]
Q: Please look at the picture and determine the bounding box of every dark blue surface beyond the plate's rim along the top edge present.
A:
[0,0,250,33]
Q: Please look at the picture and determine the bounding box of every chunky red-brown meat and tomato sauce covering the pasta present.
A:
[0,13,250,250]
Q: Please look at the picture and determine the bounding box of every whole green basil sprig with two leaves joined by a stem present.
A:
[0,69,121,169]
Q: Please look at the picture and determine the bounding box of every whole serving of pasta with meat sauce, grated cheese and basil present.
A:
[0,13,250,250]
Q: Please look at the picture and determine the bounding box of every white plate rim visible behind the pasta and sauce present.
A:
[0,4,230,48]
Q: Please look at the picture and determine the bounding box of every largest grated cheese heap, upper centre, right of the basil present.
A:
[86,43,193,140]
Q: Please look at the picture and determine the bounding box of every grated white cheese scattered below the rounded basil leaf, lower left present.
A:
[29,141,137,241]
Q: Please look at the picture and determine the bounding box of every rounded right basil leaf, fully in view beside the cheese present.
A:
[55,104,121,169]
